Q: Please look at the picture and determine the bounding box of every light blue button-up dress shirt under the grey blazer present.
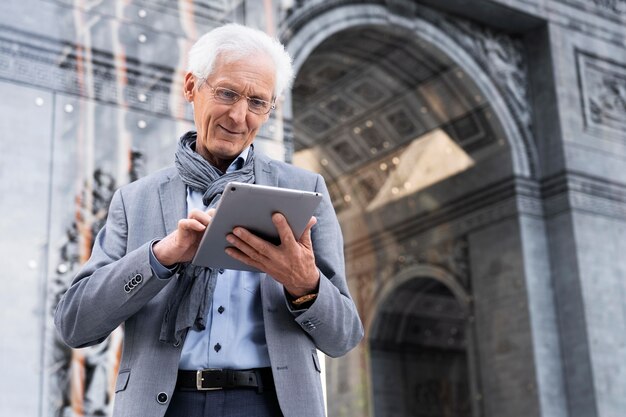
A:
[150,147,270,370]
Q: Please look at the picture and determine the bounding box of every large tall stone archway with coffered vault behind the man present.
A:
[284,5,552,416]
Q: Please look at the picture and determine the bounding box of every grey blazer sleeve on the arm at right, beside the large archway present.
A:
[294,175,364,357]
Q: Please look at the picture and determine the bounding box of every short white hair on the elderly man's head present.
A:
[187,23,294,97]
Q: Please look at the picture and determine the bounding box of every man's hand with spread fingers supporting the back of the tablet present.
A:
[226,213,320,298]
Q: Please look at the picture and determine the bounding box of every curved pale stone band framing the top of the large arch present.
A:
[282,4,538,178]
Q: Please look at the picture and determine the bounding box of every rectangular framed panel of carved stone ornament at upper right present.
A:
[576,50,626,133]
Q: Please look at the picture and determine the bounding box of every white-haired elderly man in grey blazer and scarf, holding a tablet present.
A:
[55,24,363,417]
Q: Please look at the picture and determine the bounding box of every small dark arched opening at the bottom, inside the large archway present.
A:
[368,265,472,417]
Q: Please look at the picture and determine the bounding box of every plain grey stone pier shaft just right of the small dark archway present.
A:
[468,218,548,417]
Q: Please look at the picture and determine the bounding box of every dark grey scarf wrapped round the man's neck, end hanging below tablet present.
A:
[159,132,254,346]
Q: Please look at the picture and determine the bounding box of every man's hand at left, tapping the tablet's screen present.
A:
[152,208,215,266]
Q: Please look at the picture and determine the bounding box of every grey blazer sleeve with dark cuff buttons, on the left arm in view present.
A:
[54,188,171,348]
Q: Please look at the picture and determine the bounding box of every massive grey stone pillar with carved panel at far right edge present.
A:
[543,10,626,417]
